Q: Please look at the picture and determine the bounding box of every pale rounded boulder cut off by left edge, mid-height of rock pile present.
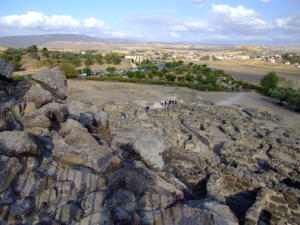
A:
[0,131,41,157]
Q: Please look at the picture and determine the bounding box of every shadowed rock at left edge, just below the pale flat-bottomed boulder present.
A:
[0,155,22,193]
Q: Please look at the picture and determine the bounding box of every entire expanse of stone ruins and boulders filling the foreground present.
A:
[0,70,300,225]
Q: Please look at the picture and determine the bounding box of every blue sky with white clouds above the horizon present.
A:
[0,0,300,46]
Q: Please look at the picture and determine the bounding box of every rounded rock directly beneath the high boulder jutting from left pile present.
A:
[23,85,54,107]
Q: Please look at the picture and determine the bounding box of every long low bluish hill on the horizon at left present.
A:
[0,34,103,47]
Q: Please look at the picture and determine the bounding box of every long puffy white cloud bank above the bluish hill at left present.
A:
[0,12,109,31]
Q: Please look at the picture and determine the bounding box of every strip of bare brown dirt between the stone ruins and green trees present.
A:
[68,80,300,130]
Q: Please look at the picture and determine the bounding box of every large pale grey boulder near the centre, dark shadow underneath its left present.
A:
[112,129,169,171]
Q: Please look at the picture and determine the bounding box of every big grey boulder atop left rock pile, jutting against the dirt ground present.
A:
[32,69,68,99]
